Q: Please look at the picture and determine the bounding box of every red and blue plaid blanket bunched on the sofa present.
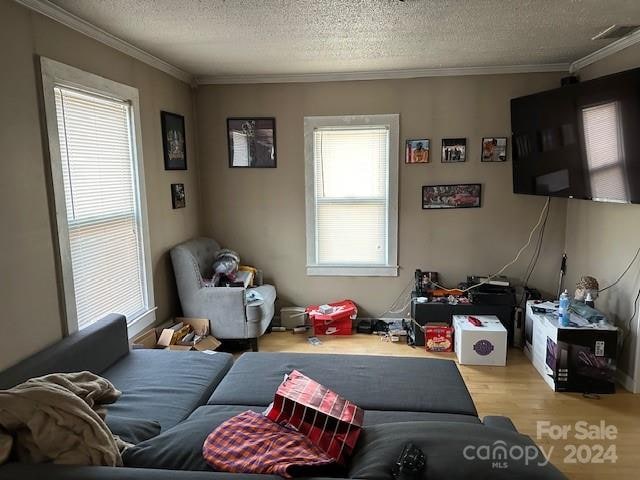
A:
[202,411,335,478]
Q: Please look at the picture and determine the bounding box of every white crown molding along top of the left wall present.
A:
[15,0,193,84]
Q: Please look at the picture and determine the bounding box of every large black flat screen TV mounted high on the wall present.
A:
[511,68,640,203]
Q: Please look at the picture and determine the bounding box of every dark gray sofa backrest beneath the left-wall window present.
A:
[0,314,129,389]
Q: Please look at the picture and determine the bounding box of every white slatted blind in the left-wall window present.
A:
[54,87,146,329]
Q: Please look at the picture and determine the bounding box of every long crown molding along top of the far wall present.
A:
[195,63,569,85]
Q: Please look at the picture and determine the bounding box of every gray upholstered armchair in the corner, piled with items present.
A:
[171,238,276,351]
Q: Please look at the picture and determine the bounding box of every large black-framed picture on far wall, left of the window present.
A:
[227,117,277,168]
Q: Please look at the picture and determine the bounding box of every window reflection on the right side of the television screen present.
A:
[582,102,629,201]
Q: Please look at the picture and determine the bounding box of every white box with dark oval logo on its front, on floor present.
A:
[453,315,507,367]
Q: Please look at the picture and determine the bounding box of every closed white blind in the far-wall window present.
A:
[313,126,389,266]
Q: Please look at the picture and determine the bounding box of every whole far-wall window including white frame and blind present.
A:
[305,115,398,276]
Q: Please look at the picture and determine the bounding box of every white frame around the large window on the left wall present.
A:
[40,57,156,338]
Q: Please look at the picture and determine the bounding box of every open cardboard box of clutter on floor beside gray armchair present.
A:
[133,318,221,351]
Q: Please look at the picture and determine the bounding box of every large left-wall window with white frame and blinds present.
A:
[42,59,154,332]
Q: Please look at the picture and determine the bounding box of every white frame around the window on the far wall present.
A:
[304,114,400,277]
